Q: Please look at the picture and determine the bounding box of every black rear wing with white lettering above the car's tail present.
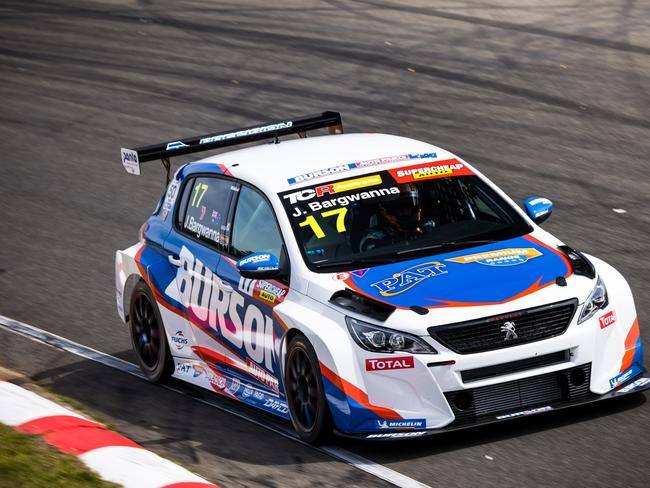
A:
[121,112,343,183]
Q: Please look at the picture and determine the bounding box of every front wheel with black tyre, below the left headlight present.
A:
[285,334,333,444]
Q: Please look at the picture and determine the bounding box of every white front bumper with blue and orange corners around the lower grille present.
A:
[326,258,645,438]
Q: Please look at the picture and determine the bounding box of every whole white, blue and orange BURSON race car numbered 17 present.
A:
[116,112,650,442]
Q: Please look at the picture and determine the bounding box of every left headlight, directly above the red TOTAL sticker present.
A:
[345,317,438,354]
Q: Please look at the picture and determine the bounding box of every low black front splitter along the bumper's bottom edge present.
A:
[336,365,650,441]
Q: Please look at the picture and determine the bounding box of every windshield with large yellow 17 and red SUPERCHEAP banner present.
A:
[280,159,532,272]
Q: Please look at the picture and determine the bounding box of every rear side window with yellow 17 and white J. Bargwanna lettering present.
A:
[178,177,233,247]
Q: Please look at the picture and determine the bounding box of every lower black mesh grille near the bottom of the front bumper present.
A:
[445,363,592,425]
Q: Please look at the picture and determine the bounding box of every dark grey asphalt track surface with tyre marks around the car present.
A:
[0,0,650,487]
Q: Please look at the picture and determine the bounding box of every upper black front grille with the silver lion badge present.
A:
[428,298,578,354]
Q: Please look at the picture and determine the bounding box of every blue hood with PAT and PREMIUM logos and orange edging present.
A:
[310,235,571,309]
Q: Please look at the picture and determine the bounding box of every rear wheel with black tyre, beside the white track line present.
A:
[129,281,174,383]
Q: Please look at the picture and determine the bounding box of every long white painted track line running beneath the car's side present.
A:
[0,315,431,488]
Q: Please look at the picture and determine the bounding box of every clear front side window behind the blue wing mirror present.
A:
[231,186,282,258]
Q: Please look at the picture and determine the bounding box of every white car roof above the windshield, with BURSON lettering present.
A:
[187,134,456,193]
